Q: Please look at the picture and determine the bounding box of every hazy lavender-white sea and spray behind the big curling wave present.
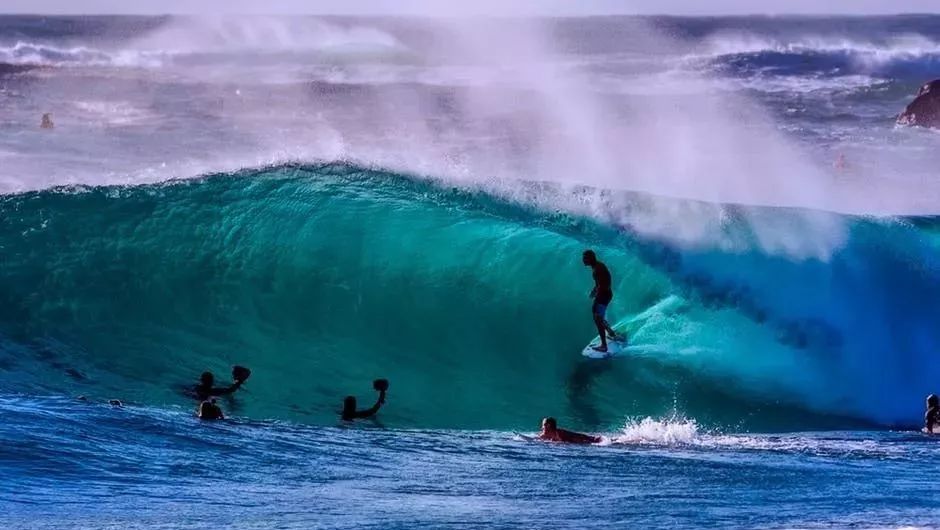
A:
[0,16,940,210]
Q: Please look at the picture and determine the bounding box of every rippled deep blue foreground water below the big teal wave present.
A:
[0,396,940,528]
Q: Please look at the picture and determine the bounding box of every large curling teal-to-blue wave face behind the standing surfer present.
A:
[0,165,940,430]
